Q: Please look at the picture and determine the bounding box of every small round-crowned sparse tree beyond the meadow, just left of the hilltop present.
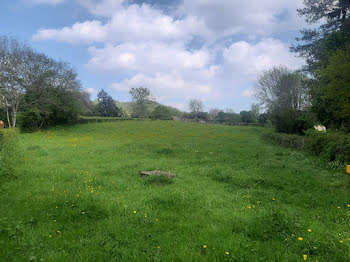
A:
[129,87,155,119]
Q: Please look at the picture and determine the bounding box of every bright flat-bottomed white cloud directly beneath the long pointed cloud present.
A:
[87,42,210,73]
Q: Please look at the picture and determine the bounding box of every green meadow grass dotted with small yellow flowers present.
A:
[0,121,350,262]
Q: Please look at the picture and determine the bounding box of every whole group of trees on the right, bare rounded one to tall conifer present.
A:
[255,0,350,134]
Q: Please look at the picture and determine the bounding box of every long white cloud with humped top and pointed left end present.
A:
[33,5,209,43]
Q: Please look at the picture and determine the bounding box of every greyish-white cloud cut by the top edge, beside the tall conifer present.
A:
[180,0,304,35]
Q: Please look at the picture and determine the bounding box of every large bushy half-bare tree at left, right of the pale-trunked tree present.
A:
[21,56,83,129]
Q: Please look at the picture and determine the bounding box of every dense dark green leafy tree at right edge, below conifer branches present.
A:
[313,45,350,132]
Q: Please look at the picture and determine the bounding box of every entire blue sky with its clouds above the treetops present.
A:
[0,0,305,112]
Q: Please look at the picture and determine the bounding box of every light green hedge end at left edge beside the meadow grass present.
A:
[0,129,23,183]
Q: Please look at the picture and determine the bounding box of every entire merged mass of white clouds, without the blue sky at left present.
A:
[33,0,303,107]
